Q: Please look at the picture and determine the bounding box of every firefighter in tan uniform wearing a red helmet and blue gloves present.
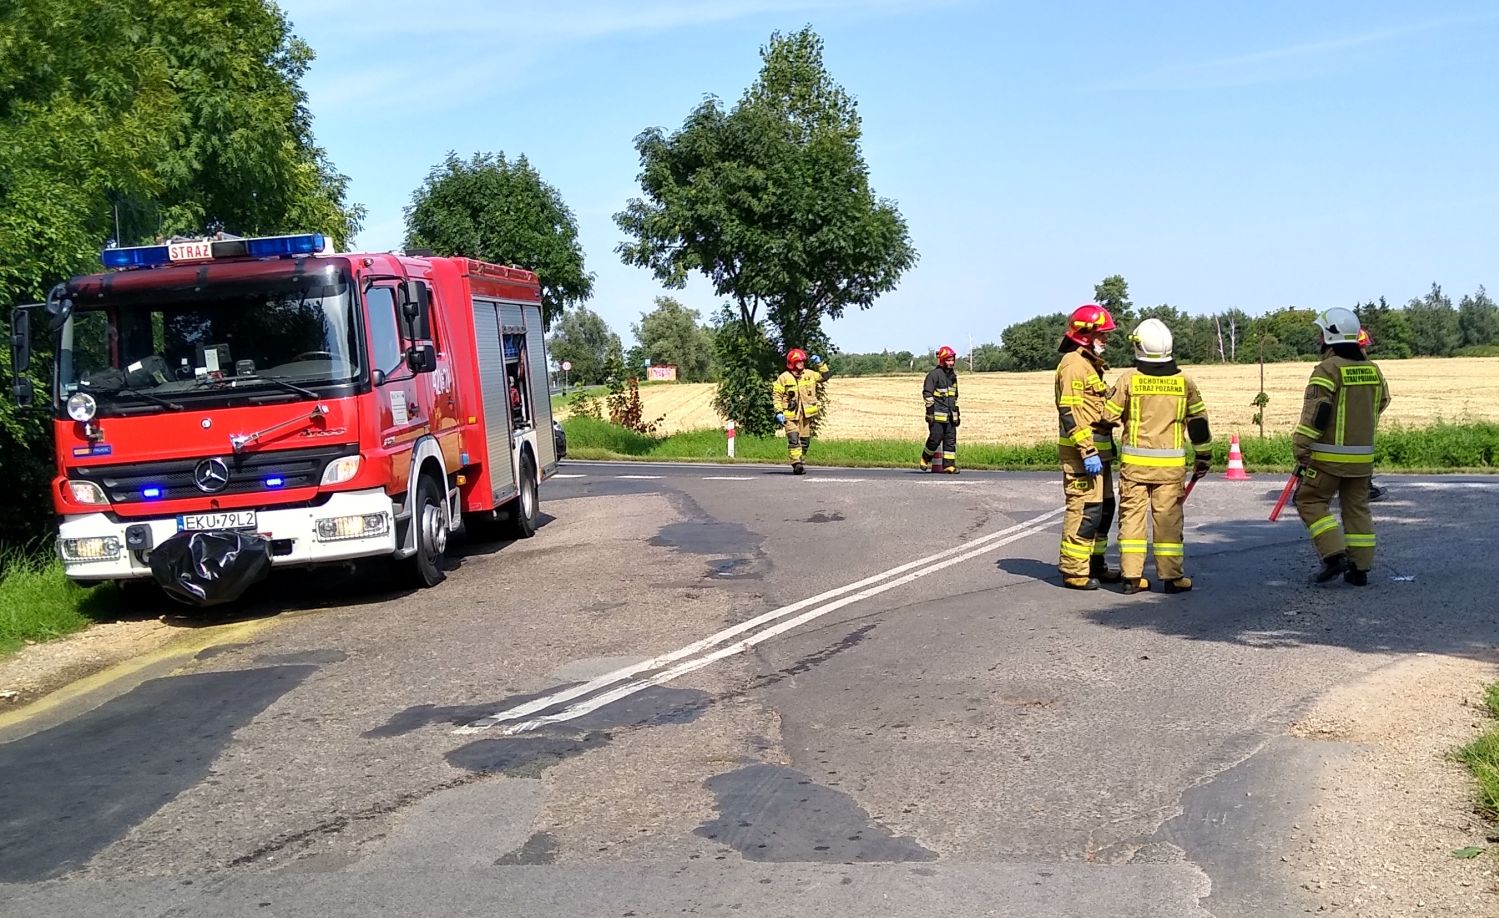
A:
[1057,303,1120,590]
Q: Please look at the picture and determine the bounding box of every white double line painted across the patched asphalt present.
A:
[456,507,1063,734]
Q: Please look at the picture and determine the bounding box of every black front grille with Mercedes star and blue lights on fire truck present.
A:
[67,446,351,504]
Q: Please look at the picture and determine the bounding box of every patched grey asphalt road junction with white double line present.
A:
[0,462,1499,918]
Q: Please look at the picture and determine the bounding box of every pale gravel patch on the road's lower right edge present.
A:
[1291,654,1499,918]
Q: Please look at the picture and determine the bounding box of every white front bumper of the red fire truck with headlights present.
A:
[57,488,396,582]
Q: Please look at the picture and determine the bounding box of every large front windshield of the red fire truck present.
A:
[57,273,364,414]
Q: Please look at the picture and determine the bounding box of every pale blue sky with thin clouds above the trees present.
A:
[282,0,1499,351]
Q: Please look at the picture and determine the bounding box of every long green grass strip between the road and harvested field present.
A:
[562,417,1499,473]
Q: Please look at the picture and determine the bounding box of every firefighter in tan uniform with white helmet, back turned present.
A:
[1103,318,1213,593]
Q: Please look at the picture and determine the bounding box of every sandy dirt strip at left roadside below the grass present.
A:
[0,620,183,714]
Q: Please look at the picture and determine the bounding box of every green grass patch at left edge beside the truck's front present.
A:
[0,554,114,656]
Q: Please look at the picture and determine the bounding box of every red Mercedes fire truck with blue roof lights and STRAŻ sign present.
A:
[12,234,558,605]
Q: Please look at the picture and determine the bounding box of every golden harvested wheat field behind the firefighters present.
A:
[590,357,1499,443]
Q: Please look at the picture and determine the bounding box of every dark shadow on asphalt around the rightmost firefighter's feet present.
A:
[1085,491,1499,659]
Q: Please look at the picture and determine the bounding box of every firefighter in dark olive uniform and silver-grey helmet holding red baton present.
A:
[1291,309,1390,587]
